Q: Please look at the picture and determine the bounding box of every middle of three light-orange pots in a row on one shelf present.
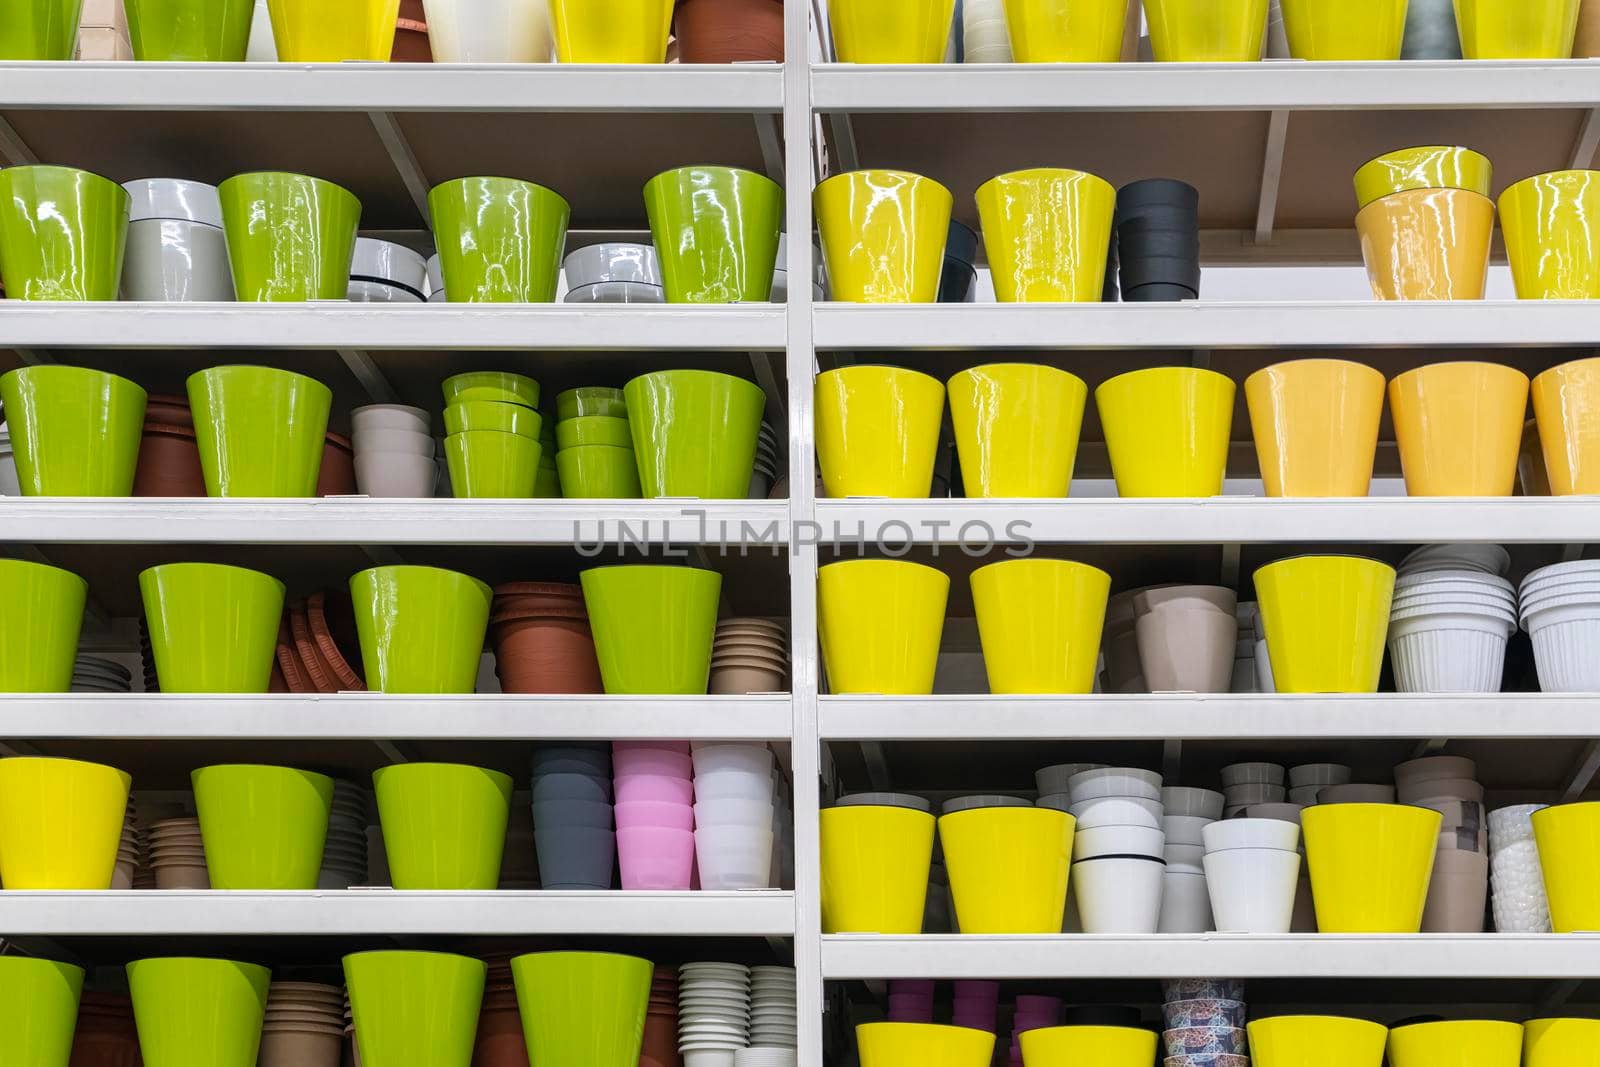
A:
[1389,362,1528,496]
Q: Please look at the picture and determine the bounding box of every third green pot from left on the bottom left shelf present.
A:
[344,952,488,1067]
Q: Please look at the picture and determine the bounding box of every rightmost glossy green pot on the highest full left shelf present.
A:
[645,166,784,304]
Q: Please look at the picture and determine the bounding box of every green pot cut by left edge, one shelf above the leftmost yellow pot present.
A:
[0,560,90,693]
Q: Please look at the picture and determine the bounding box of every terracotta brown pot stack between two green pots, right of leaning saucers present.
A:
[490,582,603,693]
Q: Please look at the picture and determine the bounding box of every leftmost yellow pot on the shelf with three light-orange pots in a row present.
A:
[814,365,944,499]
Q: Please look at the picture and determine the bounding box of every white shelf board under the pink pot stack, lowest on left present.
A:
[0,889,795,937]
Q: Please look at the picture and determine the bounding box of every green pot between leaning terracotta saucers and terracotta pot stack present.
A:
[350,566,491,693]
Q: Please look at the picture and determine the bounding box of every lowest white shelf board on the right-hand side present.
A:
[822,934,1600,979]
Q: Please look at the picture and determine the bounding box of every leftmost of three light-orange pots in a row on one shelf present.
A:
[1245,360,1384,496]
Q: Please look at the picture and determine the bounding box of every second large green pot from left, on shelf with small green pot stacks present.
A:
[189,366,333,498]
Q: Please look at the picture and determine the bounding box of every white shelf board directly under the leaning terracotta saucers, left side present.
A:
[0,693,794,741]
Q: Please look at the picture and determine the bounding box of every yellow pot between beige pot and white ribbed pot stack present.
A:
[1254,555,1395,693]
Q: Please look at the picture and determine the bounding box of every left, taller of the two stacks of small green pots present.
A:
[443,371,544,501]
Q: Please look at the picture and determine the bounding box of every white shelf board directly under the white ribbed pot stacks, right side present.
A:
[818,693,1600,741]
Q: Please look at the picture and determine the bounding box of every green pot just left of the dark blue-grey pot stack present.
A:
[373,763,510,889]
